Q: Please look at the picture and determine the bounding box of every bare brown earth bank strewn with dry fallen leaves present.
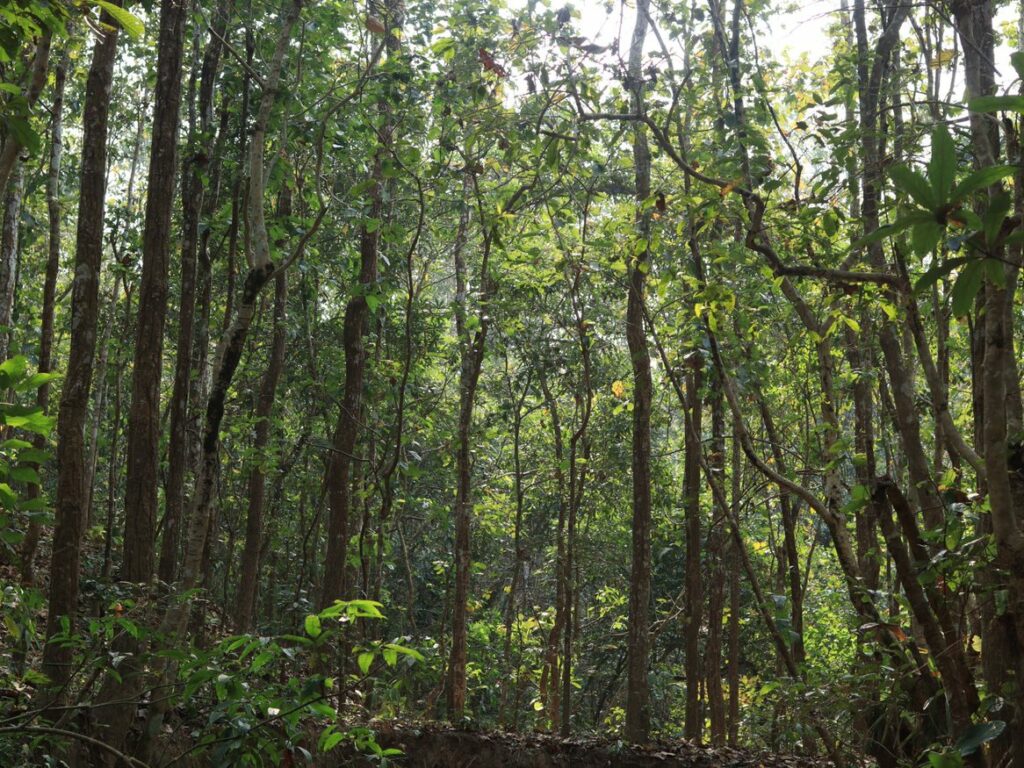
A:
[331,723,831,768]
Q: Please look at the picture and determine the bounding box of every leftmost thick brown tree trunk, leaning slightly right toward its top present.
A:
[43,6,118,684]
